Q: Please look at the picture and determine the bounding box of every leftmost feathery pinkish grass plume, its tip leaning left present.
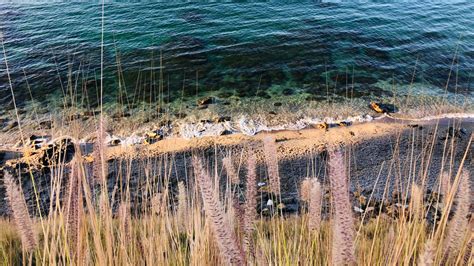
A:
[3,171,38,251]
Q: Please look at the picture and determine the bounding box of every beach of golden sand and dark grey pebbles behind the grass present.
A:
[0,115,474,216]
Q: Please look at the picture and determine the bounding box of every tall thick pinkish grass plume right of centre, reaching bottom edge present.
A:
[328,148,355,265]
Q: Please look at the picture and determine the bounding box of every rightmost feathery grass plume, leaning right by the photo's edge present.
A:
[444,170,471,256]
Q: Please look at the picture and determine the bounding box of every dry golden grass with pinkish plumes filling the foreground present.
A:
[0,126,473,265]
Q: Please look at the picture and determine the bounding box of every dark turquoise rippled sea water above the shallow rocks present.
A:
[0,1,474,106]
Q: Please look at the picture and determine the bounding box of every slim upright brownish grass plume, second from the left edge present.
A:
[66,159,82,254]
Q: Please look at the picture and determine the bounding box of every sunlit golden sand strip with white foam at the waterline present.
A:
[0,110,474,161]
